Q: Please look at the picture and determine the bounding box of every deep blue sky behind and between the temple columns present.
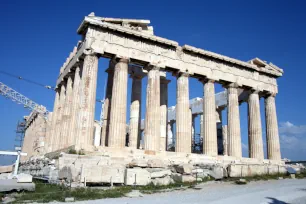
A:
[0,0,306,163]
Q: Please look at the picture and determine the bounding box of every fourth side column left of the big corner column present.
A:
[47,89,60,152]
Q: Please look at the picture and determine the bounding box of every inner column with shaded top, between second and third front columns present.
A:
[129,74,143,149]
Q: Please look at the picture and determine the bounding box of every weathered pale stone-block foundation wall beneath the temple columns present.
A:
[19,151,286,185]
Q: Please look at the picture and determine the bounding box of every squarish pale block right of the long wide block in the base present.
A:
[125,168,151,186]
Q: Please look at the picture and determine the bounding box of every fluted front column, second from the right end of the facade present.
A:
[248,90,264,159]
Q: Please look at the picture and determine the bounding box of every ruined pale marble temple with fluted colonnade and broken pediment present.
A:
[19,13,284,183]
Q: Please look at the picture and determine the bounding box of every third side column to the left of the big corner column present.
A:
[53,84,66,151]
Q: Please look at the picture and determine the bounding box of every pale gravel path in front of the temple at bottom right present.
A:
[51,179,306,204]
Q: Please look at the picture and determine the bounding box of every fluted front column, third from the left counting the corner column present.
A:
[144,66,160,152]
